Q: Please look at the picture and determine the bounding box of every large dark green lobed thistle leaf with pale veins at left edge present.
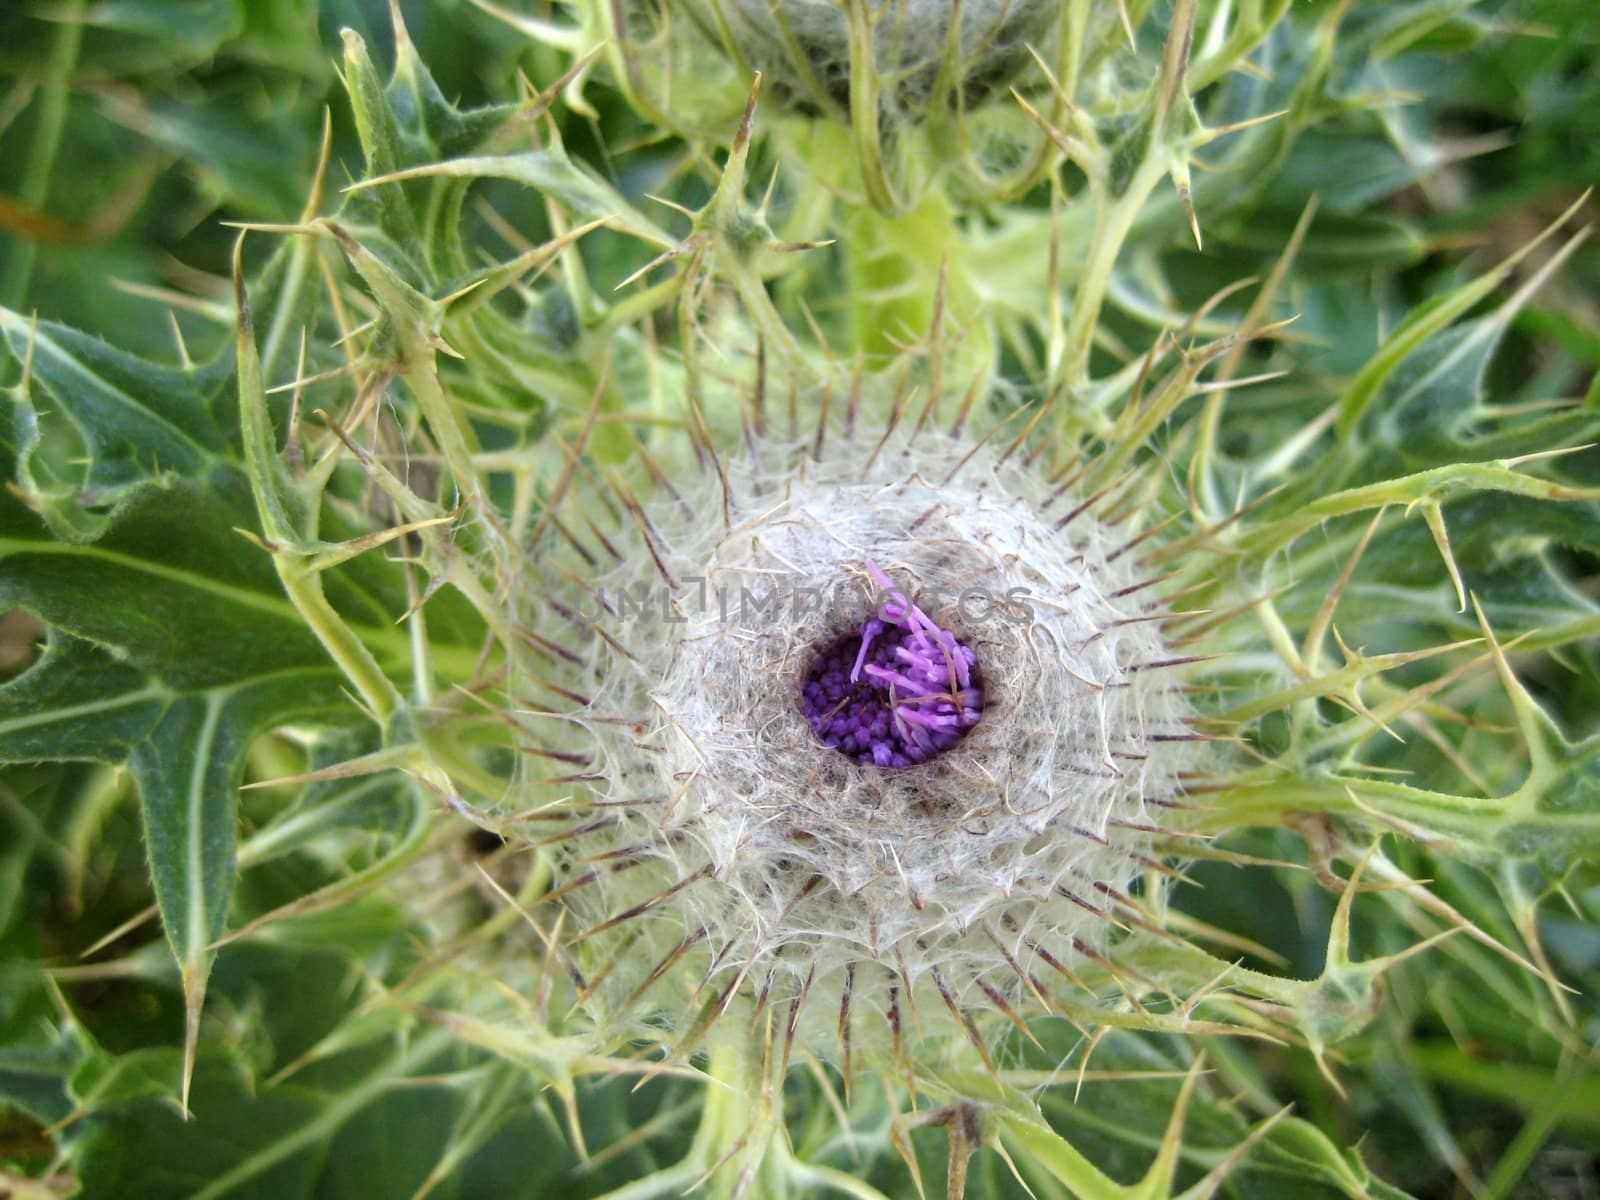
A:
[0,323,387,1107]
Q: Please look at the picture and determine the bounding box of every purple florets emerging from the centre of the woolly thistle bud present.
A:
[800,560,984,770]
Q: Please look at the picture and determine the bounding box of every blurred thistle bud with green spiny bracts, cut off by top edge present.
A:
[606,0,1120,214]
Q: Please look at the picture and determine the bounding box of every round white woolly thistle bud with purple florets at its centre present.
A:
[505,416,1189,1054]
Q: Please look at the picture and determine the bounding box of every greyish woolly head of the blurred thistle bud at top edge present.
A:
[699,0,1061,122]
